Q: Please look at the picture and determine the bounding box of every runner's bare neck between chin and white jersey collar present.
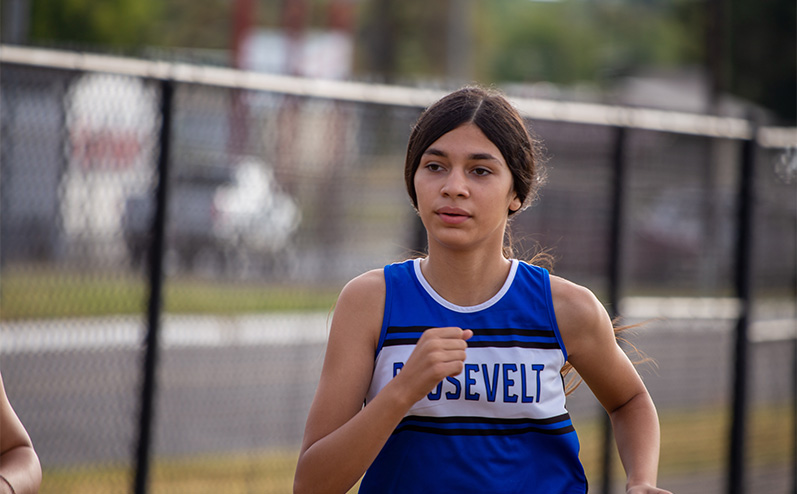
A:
[421,245,511,307]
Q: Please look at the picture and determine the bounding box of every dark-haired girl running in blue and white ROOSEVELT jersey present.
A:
[294,88,666,494]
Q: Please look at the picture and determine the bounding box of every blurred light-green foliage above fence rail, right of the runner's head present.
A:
[484,0,694,84]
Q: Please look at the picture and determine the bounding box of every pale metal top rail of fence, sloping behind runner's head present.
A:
[0,45,797,148]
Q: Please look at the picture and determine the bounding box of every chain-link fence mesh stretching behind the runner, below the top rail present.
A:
[0,44,797,494]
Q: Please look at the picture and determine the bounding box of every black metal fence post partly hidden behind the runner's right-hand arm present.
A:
[601,127,627,494]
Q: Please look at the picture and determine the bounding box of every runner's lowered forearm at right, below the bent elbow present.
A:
[611,391,660,489]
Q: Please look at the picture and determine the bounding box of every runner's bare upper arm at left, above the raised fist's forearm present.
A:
[302,270,386,451]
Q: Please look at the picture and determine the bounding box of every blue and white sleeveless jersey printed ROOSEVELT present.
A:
[360,259,587,494]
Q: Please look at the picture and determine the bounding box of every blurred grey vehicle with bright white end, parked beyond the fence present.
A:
[123,157,300,275]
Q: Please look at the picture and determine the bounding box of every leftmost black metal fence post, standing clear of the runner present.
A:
[133,80,174,494]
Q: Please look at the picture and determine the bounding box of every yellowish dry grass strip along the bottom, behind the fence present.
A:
[41,405,794,494]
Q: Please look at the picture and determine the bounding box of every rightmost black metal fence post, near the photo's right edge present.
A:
[728,132,756,494]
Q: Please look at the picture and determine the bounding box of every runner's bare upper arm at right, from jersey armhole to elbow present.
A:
[551,276,646,413]
